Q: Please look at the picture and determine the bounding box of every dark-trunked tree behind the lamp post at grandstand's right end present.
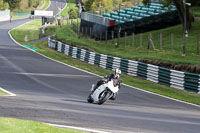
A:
[143,0,194,30]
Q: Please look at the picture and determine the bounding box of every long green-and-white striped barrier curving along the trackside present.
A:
[48,38,200,94]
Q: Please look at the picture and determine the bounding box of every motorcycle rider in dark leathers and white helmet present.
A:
[92,68,121,100]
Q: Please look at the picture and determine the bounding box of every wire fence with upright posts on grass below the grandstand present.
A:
[68,21,200,55]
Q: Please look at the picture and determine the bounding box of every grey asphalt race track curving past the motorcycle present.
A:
[0,1,200,133]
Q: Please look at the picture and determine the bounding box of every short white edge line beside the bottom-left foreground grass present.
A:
[46,123,110,133]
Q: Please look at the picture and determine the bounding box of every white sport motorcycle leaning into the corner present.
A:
[87,79,119,105]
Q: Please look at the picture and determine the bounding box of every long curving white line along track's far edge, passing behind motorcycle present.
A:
[8,8,200,107]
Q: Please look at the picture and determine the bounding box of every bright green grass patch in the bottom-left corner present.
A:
[0,117,83,133]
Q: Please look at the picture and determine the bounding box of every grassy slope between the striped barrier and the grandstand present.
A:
[56,21,200,65]
